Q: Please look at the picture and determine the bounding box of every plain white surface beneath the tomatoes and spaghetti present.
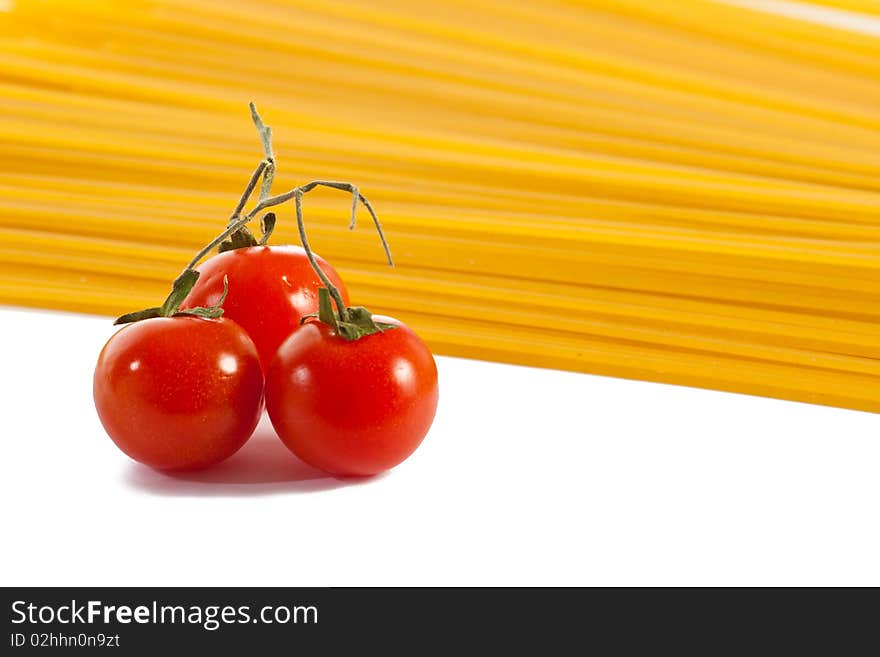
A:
[0,308,880,586]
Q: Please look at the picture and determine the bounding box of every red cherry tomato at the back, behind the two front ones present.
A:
[181,246,348,371]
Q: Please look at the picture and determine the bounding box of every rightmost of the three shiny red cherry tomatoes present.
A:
[266,316,438,475]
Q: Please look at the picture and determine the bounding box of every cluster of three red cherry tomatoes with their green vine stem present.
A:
[94,105,438,475]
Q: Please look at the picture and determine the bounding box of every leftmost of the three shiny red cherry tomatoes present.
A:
[94,316,263,470]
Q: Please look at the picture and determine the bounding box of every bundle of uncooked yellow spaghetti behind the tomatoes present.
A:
[0,0,880,411]
